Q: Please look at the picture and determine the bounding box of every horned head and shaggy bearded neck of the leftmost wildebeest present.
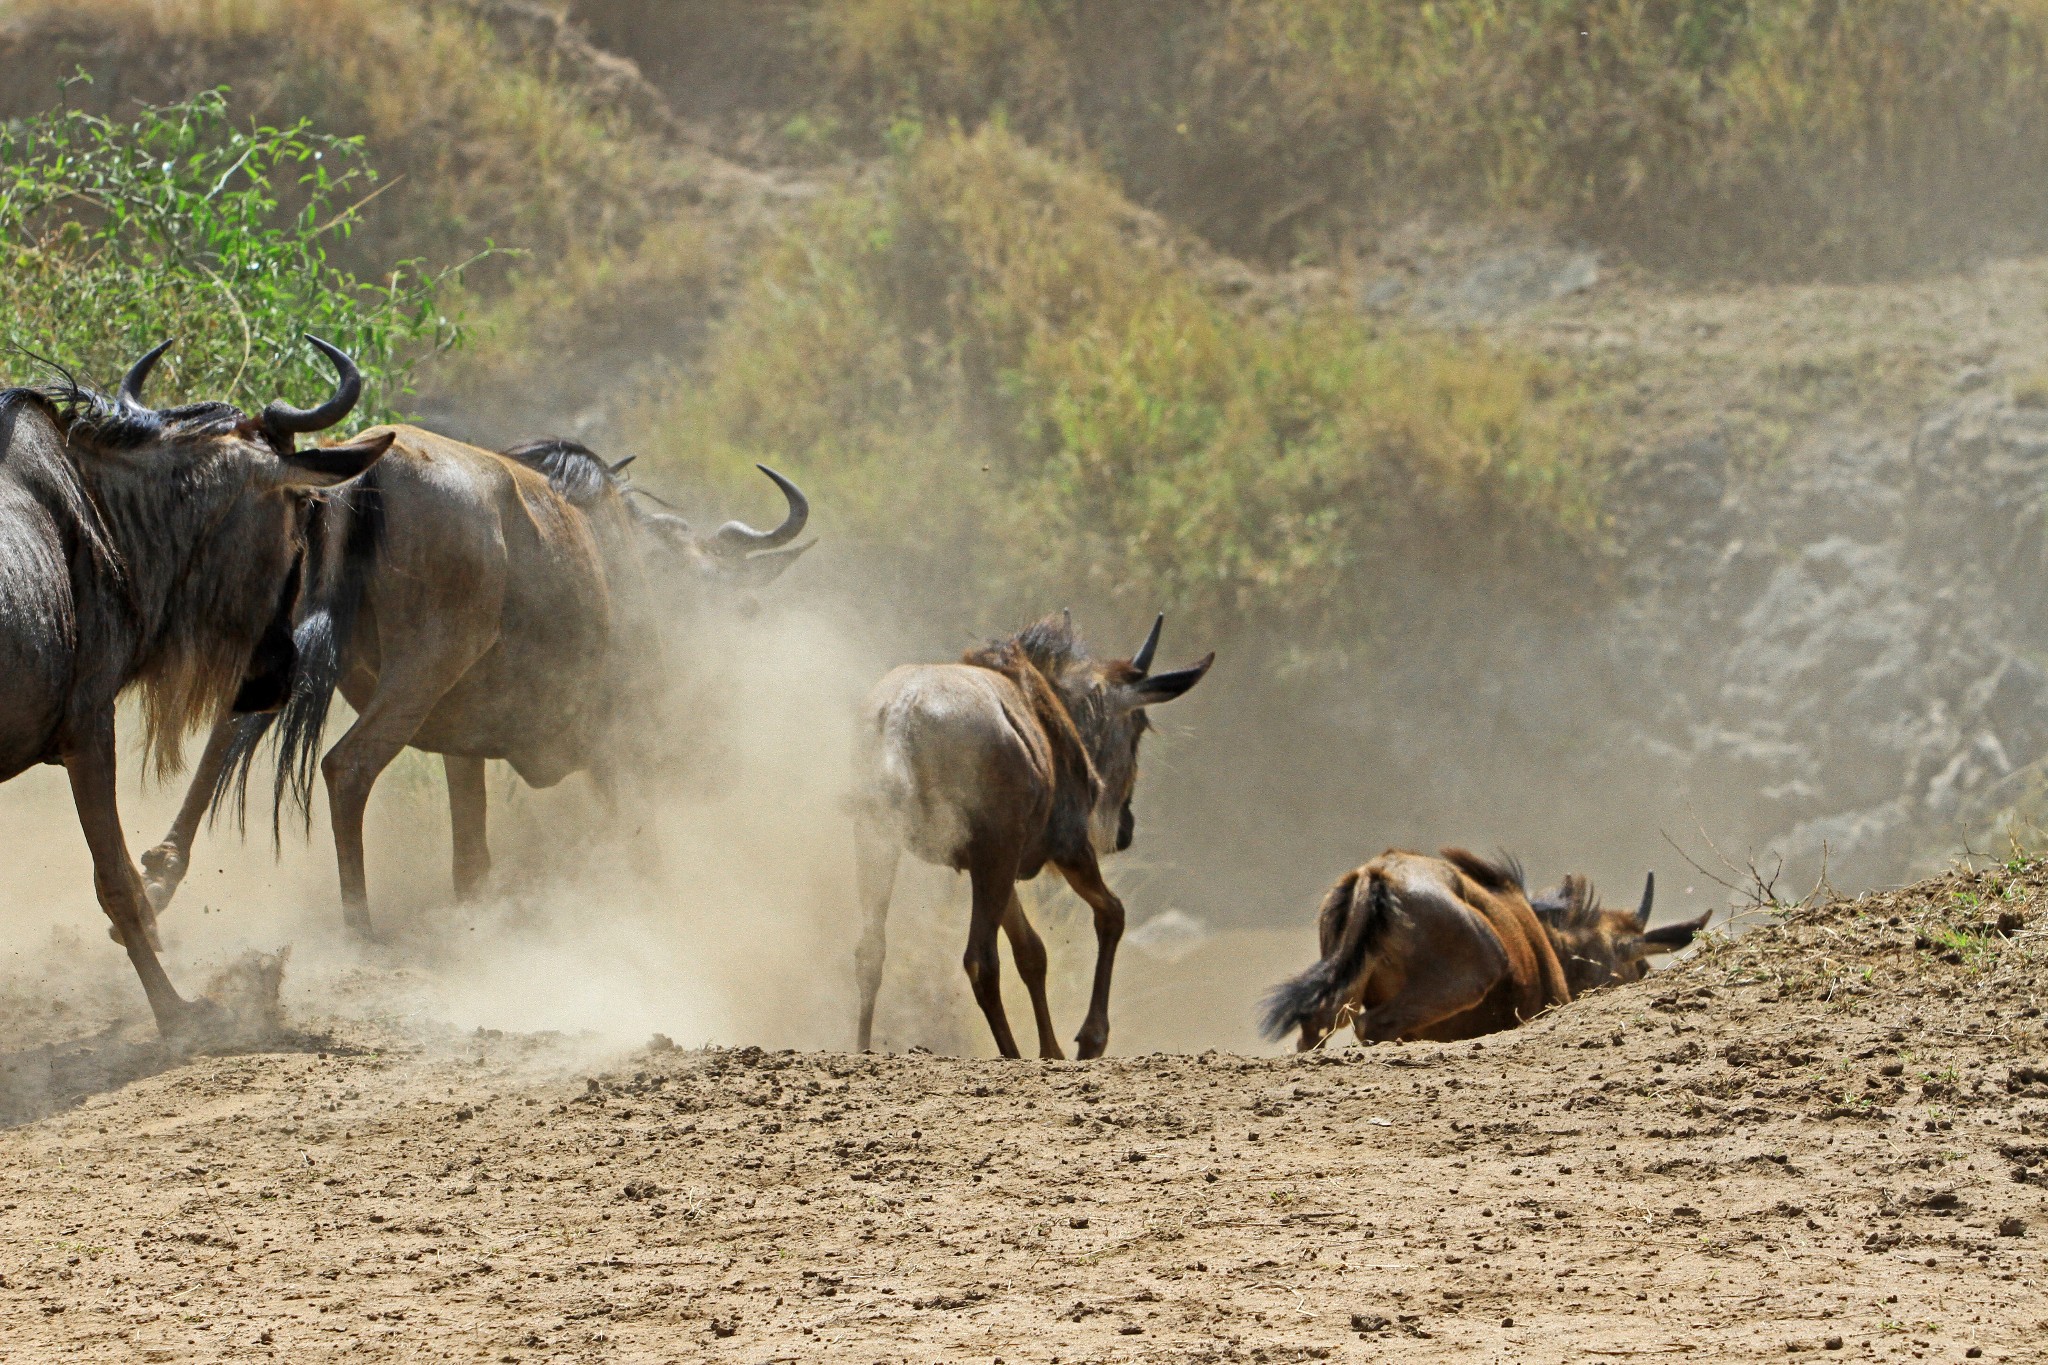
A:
[49,338,391,765]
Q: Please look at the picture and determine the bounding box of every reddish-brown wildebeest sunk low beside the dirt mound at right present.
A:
[1264,849,1706,1050]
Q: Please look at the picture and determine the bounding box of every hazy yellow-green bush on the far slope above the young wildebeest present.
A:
[639,125,1604,645]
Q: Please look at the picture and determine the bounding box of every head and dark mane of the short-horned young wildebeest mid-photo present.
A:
[1016,612,1217,851]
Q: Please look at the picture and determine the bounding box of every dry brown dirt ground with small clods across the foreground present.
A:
[0,866,2048,1363]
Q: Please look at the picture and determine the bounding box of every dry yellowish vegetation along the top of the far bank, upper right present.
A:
[589,0,2048,276]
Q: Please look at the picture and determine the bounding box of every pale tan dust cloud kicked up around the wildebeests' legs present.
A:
[0,548,1303,1070]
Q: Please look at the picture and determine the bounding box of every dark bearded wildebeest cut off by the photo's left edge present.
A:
[0,340,391,1033]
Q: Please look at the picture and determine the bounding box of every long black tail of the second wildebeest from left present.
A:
[213,480,385,839]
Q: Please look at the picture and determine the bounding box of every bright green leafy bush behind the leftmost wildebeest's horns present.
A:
[0,90,461,420]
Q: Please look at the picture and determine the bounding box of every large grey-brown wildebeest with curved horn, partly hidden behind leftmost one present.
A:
[143,426,809,937]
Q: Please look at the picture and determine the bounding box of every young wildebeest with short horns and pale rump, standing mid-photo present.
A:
[854,616,1217,1058]
